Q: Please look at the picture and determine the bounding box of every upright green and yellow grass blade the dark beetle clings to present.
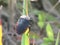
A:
[21,0,29,45]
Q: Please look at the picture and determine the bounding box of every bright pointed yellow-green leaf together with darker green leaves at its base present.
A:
[41,23,54,45]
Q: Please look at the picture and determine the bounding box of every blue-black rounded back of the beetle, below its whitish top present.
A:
[16,18,29,34]
